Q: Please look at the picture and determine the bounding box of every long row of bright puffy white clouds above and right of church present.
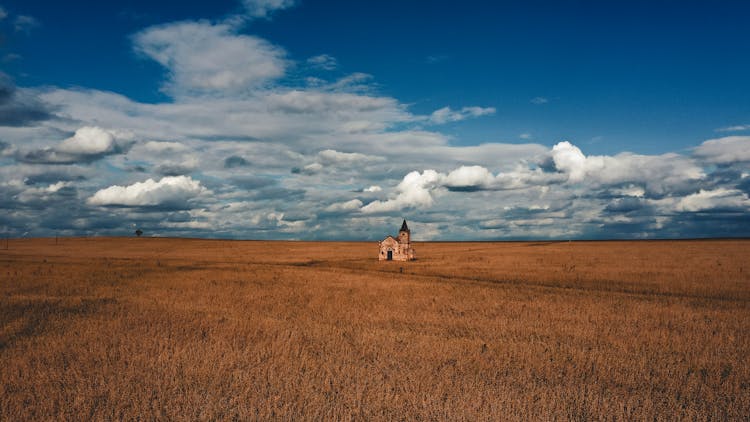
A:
[361,142,705,213]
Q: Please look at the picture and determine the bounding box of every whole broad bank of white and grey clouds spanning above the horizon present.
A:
[0,0,750,240]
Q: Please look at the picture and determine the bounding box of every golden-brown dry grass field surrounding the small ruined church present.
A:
[0,238,750,421]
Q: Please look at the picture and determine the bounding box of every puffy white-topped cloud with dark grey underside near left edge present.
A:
[18,126,133,164]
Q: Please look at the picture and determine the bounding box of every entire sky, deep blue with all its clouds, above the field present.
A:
[0,0,750,240]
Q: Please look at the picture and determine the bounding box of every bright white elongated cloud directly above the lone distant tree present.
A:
[88,176,207,207]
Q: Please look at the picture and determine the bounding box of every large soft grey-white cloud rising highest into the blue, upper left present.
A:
[133,21,287,96]
